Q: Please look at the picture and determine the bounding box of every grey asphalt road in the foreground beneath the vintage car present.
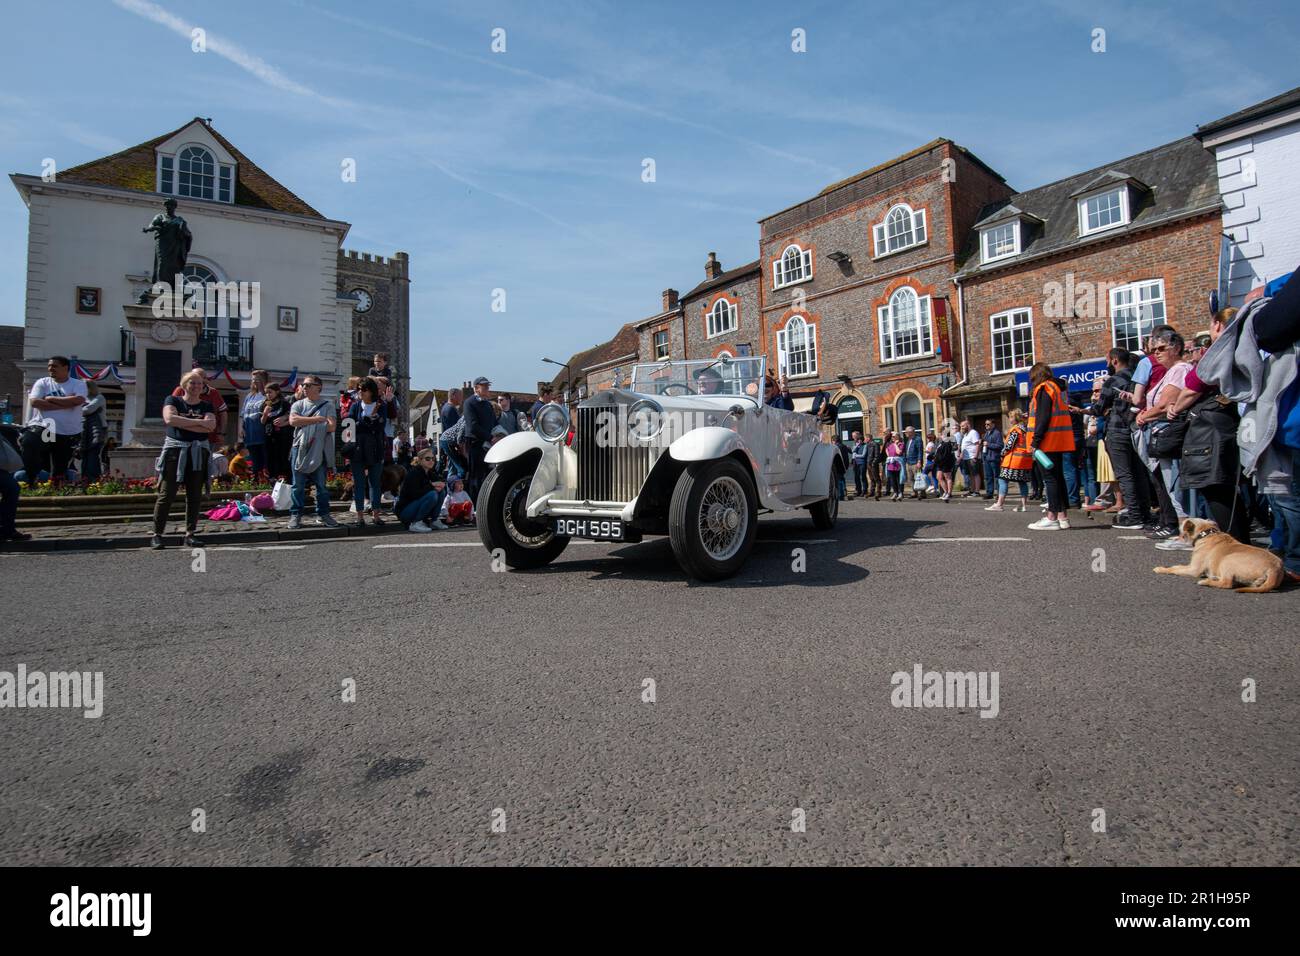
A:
[0,502,1300,865]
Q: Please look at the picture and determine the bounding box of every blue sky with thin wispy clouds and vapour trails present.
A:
[0,0,1300,390]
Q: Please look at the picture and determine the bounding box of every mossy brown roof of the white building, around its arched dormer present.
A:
[59,117,325,219]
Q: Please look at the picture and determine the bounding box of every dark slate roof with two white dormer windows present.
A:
[957,137,1222,278]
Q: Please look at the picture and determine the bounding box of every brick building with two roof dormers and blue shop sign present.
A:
[945,137,1222,421]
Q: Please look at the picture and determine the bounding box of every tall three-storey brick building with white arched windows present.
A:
[759,139,1011,434]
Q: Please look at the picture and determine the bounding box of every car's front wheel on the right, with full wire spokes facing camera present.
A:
[668,458,758,581]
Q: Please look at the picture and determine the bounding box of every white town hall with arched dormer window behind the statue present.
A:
[10,118,406,463]
